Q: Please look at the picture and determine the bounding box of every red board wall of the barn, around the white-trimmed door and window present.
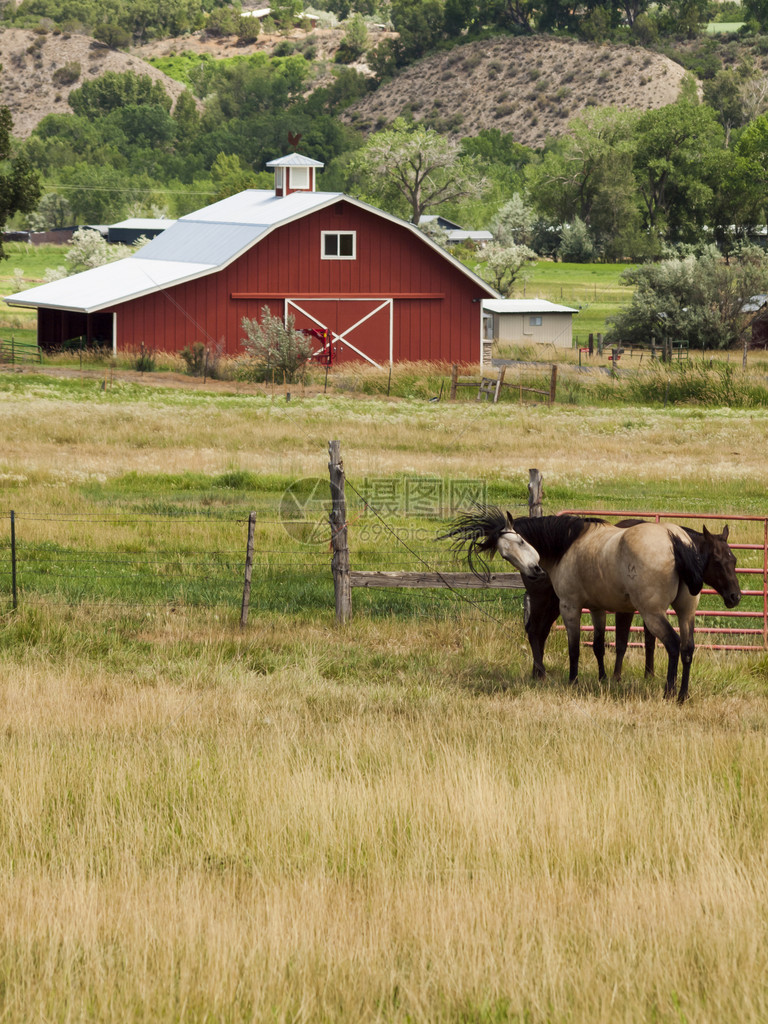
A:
[105,201,488,362]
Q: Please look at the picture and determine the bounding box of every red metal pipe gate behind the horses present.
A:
[559,509,768,650]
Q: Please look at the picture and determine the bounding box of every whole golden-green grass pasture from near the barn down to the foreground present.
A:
[0,373,768,1024]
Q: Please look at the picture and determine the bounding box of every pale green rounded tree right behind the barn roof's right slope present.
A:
[349,118,486,224]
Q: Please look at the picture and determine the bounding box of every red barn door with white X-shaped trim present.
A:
[286,298,392,367]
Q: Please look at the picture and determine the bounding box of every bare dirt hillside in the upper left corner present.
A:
[0,29,190,138]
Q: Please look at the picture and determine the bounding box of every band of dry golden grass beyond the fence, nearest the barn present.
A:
[0,381,768,484]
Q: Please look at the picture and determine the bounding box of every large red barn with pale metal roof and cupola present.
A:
[5,154,498,366]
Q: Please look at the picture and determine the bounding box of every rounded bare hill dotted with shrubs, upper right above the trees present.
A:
[344,36,685,146]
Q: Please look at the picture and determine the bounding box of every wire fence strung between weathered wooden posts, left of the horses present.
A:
[0,497,522,617]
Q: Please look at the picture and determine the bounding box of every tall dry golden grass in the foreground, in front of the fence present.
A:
[0,605,768,1024]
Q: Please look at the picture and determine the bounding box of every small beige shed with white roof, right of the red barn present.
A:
[482,299,579,348]
